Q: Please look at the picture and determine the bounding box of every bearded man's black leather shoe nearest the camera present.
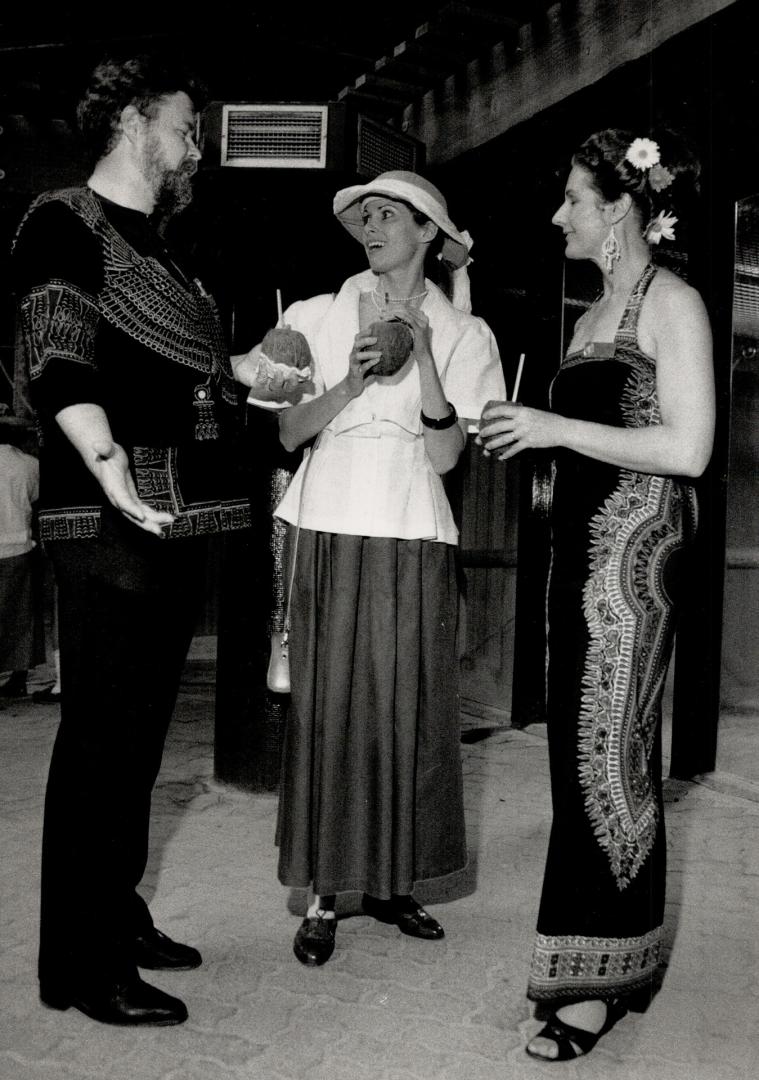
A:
[40,977,187,1027]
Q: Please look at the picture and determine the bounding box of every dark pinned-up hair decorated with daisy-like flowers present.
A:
[572,127,701,231]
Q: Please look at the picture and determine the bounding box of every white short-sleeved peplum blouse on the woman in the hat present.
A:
[265,270,505,544]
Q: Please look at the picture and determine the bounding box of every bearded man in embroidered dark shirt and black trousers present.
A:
[14,56,283,1024]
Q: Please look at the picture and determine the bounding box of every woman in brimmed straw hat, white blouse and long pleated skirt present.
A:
[264,172,503,964]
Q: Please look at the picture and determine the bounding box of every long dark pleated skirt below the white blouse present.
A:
[277,529,466,897]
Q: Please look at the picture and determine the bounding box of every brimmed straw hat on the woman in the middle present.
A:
[333,170,472,269]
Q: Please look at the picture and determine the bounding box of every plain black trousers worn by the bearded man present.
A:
[39,521,207,986]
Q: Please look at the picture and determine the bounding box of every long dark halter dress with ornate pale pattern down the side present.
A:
[528,265,696,1007]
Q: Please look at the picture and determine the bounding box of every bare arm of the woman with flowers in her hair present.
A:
[478,283,715,476]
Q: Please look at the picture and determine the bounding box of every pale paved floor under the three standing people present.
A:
[0,648,759,1080]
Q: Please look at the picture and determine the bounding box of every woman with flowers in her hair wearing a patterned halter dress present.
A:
[479,130,714,1061]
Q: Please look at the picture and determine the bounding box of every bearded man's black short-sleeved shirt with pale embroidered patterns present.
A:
[14,188,250,540]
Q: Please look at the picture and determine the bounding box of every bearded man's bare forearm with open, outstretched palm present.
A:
[55,403,174,537]
